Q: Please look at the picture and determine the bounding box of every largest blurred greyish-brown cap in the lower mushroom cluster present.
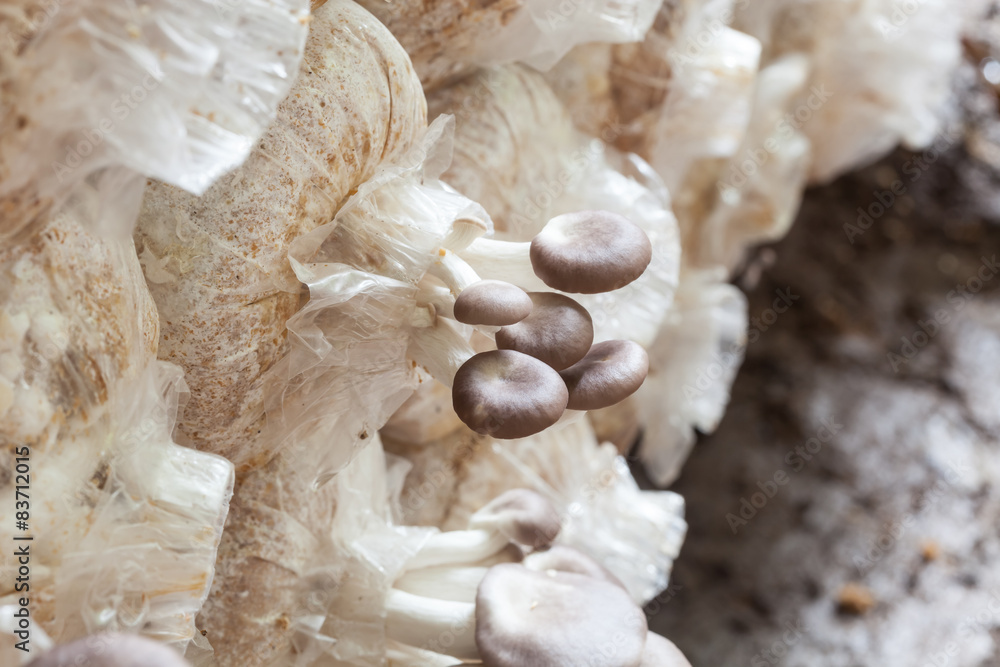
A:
[476,564,648,667]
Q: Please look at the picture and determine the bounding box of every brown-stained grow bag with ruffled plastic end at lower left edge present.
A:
[0,201,233,649]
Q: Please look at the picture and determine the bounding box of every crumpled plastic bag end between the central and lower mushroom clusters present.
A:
[386,420,687,602]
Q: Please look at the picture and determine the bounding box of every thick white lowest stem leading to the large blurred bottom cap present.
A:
[385,588,479,660]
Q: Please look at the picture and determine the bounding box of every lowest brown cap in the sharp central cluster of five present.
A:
[451,350,569,439]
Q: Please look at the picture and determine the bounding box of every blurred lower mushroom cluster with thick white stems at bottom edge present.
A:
[386,489,688,667]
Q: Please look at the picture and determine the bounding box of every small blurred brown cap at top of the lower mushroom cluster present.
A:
[469,489,562,549]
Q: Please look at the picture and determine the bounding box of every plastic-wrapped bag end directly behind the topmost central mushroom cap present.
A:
[429,66,680,344]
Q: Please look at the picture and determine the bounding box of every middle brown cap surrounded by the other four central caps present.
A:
[496,292,594,371]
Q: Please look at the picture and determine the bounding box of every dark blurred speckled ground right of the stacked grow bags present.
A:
[650,44,1000,667]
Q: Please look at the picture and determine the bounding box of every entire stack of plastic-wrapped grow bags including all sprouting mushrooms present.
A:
[0,0,960,667]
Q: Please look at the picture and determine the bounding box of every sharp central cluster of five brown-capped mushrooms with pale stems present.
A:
[413,211,652,439]
